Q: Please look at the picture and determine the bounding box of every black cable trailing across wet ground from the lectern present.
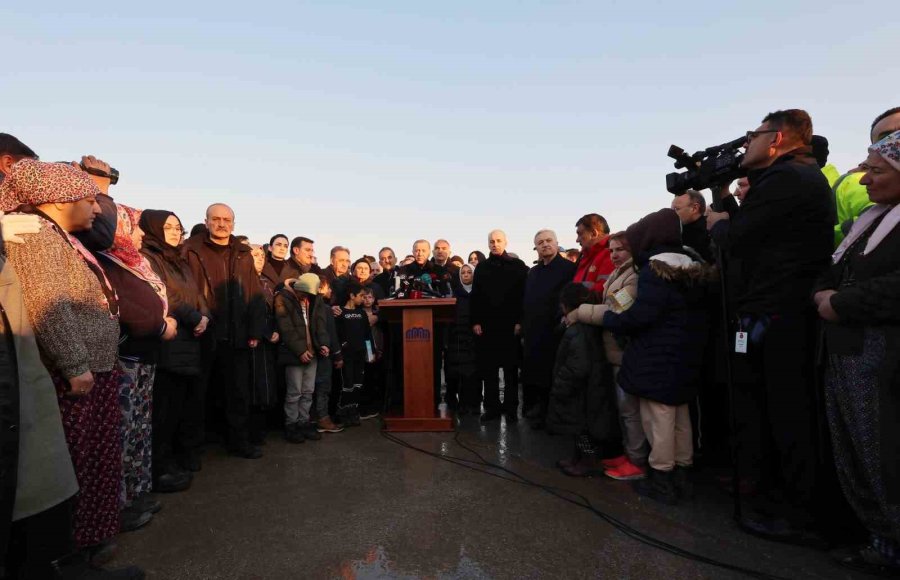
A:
[381,430,788,580]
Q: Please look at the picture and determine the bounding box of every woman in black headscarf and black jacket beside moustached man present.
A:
[138,209,210,492]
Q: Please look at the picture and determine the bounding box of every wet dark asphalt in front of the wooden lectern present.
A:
[111,417,864,580]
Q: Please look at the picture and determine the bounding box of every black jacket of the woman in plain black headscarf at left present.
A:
[141,237,210,376]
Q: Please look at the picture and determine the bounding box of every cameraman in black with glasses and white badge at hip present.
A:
[707,109,834,543]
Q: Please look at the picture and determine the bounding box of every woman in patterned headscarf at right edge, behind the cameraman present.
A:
[814,131,900,574]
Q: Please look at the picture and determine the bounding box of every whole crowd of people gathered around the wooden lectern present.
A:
[0,108,900,578]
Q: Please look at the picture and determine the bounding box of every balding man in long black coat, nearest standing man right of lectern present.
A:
[472,230,528,423]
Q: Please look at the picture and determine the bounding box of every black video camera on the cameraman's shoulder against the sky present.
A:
[666,136,747,195]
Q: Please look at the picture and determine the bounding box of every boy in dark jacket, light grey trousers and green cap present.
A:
[275,274,331,443]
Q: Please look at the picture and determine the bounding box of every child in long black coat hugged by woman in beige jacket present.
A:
[547,282,622,476]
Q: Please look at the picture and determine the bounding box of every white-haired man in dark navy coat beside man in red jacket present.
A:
[522,230,575,429]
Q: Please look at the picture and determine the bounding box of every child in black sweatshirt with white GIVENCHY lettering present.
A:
[337,279,372,427]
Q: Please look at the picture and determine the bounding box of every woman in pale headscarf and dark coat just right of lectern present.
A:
[446,264,481,415]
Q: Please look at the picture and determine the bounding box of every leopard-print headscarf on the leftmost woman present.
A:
[0,159,101,211]
